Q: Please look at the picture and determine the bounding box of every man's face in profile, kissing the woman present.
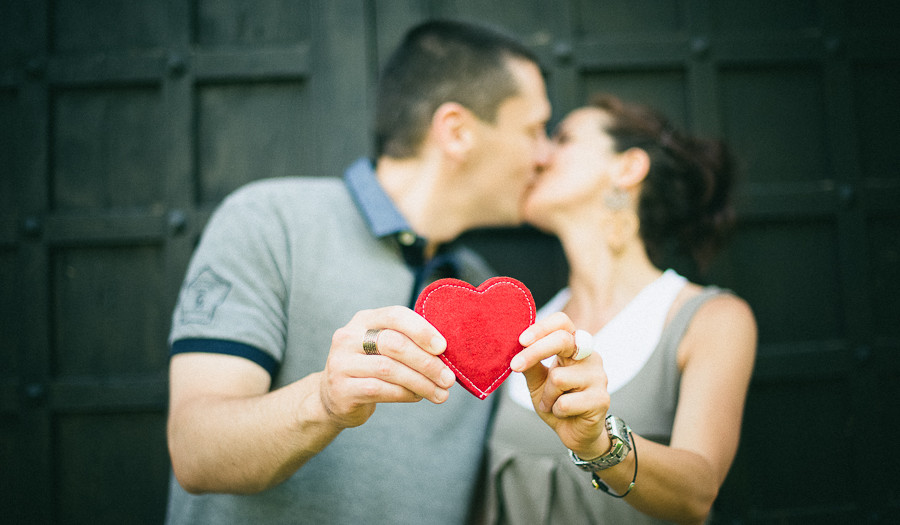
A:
[471,60,550,226]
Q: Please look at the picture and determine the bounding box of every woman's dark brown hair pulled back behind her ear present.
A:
[590,94,735,272]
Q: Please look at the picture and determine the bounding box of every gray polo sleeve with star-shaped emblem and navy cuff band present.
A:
[169,185,289,375]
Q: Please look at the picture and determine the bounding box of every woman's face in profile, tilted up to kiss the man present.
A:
[524,108,616,231]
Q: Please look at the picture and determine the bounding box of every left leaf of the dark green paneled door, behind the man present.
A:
[0,0,370,523]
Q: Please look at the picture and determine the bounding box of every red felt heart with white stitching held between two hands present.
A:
[416,277,535,399]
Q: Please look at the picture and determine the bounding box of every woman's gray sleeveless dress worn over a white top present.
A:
[482,287,724,525]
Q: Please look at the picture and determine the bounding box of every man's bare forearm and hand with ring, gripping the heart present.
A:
[168,307,455,493]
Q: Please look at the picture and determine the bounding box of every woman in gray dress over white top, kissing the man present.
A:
[485,96,756,524]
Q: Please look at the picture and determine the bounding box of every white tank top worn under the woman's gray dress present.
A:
[506,270,687,409]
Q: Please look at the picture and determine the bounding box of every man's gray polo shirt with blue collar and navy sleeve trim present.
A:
[168,161,491,524]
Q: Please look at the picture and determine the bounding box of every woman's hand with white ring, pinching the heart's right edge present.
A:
[510,312,610,459]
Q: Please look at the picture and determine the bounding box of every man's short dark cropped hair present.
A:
[375,20,538,158]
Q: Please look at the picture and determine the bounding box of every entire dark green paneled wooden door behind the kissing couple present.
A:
[0,0,900,523]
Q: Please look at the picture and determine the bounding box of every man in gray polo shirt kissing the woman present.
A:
[168,21,550,523]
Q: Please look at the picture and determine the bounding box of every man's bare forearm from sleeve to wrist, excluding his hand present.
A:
[168,353,330,493]
